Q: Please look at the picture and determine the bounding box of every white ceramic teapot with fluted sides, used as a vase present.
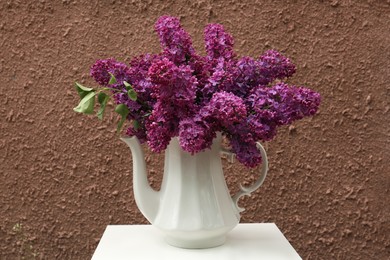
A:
[122,134,268,248]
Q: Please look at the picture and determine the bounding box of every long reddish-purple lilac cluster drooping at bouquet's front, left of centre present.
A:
[146,58,197,151]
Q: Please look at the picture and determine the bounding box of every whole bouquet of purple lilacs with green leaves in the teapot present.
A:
[74,16,320,167]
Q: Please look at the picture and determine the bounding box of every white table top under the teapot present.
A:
[92,223,301,260]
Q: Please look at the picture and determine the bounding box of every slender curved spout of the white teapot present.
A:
[121,136,160,224]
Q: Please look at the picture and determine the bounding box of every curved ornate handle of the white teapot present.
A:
[222,142,268,212]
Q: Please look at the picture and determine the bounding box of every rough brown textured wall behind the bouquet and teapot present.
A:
[0,0,390,259]
